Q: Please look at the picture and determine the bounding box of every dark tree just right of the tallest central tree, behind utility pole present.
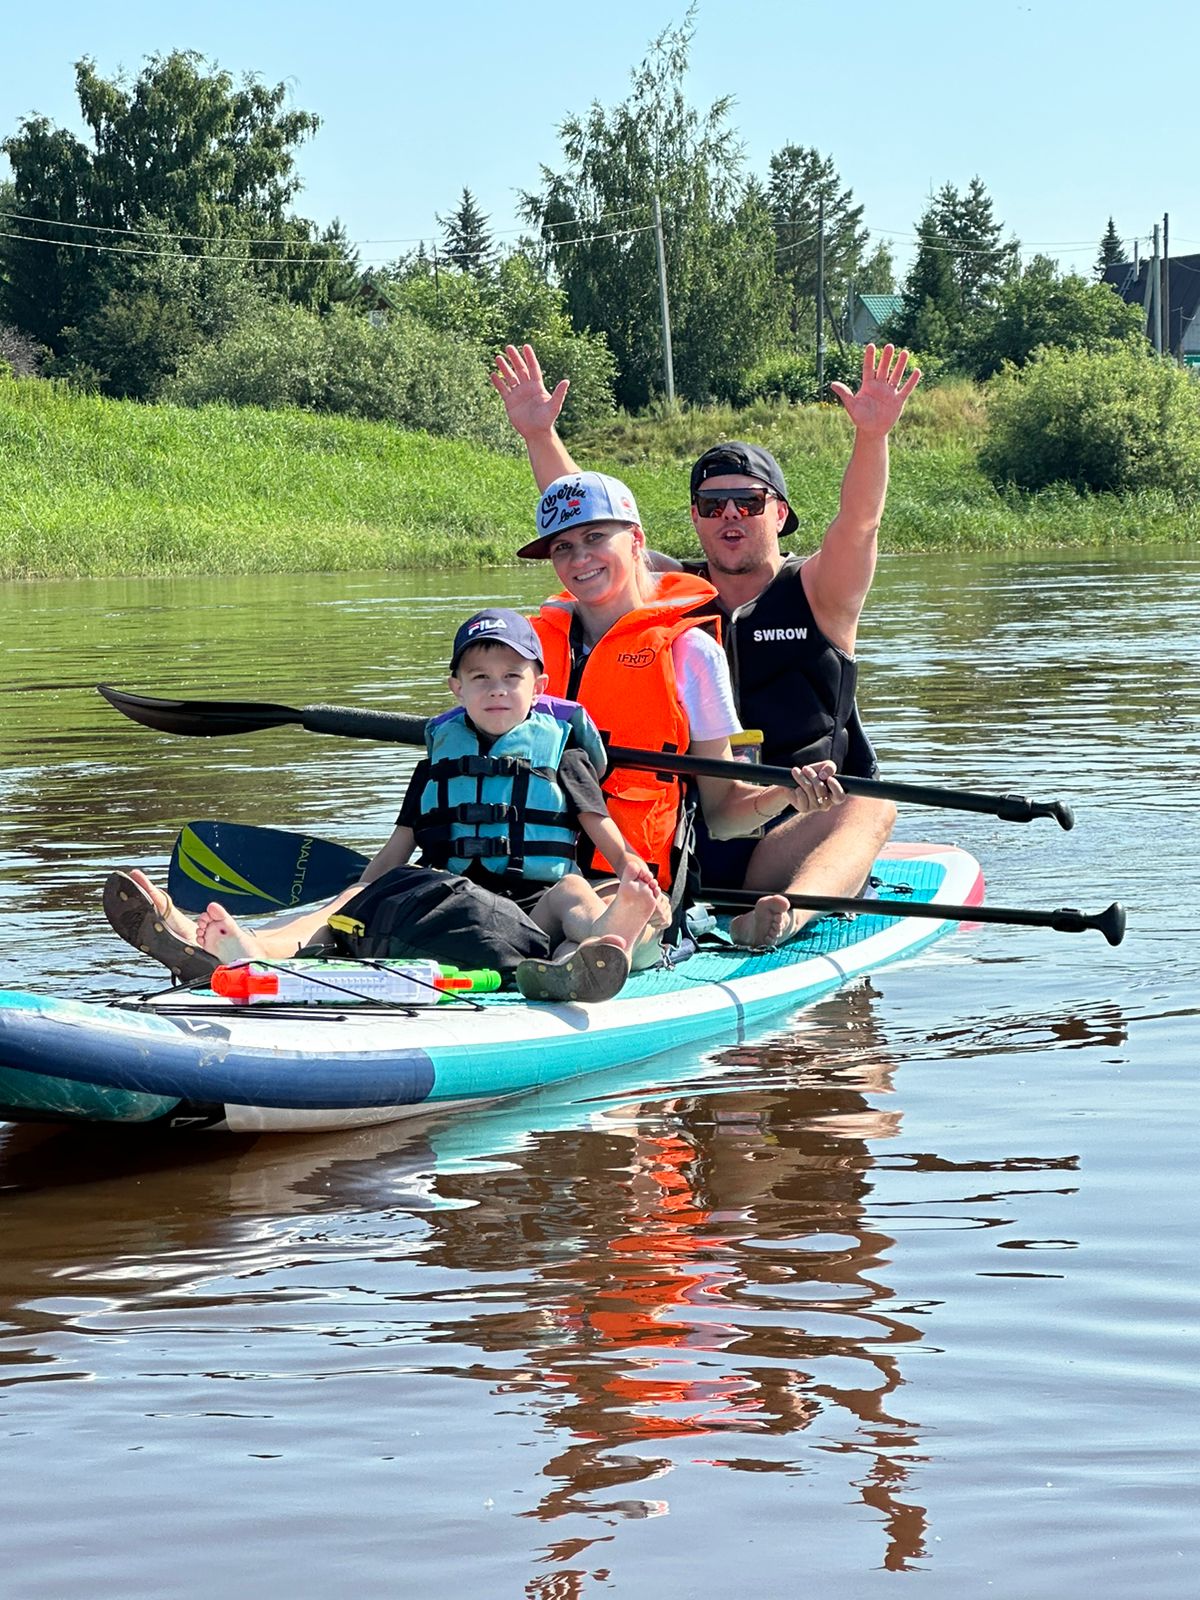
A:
[766,144,867,344]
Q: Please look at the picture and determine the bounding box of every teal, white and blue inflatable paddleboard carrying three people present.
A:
[0,845,984,1131]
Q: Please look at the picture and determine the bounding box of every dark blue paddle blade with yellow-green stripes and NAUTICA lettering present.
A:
[166,822,366,917]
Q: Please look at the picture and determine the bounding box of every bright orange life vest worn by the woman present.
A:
[533,573,720,890]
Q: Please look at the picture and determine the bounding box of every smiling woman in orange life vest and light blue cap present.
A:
[517,472,845,947]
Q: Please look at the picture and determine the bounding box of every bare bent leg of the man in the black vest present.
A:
[730,795,896,949]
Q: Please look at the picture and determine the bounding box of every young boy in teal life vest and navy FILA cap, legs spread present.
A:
[104,608,669,1000]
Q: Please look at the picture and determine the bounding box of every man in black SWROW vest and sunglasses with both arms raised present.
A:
[491,344,920,946]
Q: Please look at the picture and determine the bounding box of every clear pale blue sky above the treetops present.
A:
[0,0,1200,274]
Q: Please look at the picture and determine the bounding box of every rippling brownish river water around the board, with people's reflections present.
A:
[0,552,1200,1600]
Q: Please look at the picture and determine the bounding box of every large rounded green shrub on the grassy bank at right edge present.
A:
[981,338,1200,499]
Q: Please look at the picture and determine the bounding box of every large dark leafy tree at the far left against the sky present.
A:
[0,51,354,382]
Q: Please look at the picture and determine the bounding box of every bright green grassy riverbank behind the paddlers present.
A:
[0,379,1200,578]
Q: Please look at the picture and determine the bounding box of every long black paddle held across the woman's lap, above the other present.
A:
[96,683,1075,829]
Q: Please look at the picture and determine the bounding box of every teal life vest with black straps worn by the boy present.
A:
[414,701,605,883]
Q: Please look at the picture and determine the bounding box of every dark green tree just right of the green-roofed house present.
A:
[893,178,1018,357]
